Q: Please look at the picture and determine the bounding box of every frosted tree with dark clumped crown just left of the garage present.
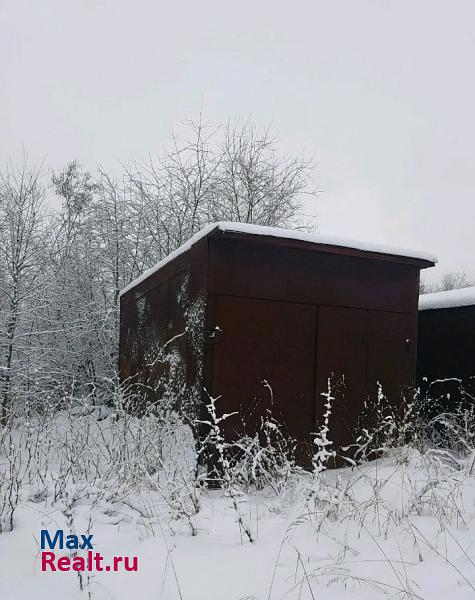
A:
[43,161,125,392]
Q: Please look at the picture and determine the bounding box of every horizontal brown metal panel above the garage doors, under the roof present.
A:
[209,238,419,314]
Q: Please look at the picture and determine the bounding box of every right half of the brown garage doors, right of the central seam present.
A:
[315,306,417,445]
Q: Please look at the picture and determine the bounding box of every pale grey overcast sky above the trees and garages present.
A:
[0,0,475,279]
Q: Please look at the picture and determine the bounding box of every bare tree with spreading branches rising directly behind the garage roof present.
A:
[124,118,314,264]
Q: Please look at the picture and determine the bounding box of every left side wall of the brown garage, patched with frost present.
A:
[119,238,208,412]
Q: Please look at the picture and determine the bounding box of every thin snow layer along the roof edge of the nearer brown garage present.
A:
[120,221,437,296]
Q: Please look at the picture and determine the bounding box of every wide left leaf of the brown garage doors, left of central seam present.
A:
[212,296,317,454]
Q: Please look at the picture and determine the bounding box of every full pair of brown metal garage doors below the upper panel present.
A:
[212,296,417,445]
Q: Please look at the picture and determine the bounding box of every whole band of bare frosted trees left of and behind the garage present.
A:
[0,116,312,406]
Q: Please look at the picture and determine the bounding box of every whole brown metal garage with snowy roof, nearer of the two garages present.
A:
[120,223,435,462]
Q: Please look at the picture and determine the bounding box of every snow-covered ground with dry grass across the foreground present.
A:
[0,410,475,600]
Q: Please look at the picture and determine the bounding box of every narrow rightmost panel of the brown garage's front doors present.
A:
[367,311,417,406]
